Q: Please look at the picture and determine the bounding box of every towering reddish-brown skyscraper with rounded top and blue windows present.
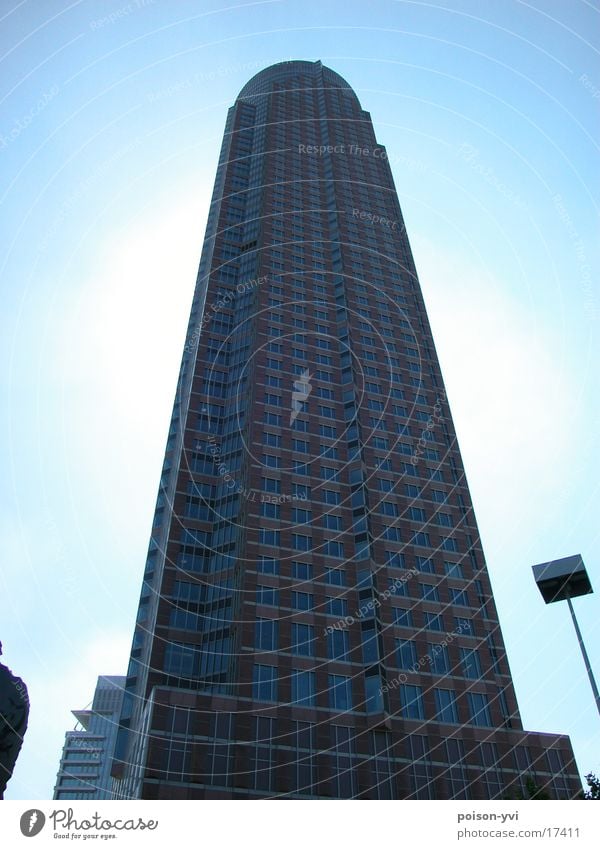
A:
[113,61,580,799]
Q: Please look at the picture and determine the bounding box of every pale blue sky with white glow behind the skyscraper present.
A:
[0,0,600,799]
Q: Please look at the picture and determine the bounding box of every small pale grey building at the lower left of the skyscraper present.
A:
[52,675,125,799]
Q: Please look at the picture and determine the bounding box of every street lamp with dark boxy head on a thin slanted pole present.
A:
[533,554,600,713]
